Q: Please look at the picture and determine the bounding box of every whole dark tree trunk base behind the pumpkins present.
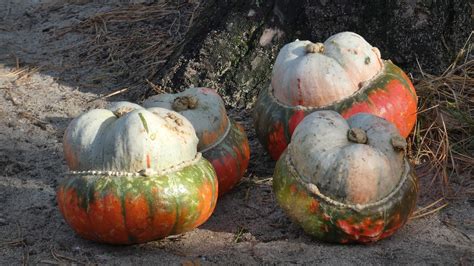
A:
[149,0,473,108]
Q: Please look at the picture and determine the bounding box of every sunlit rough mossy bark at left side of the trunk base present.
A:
[149,0,309,108]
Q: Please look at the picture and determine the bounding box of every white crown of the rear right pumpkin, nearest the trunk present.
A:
[271,32,384,107]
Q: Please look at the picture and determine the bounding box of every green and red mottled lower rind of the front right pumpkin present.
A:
[273,151,418,243]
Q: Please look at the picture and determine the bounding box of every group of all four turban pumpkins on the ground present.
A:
[57,32,417,244]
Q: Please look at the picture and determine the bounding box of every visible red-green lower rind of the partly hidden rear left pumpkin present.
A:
[203,119,250,195]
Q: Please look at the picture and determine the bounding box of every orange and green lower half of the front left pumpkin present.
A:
[57,158,218,244]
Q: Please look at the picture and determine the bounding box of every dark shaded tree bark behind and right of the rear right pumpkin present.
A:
[305,0,473,74]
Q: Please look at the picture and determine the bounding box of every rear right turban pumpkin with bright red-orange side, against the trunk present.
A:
[254,32,417,160]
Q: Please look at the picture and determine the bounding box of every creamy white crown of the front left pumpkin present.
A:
[63,102,198,173]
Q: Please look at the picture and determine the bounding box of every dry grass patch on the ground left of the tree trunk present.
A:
[58,1,199,95]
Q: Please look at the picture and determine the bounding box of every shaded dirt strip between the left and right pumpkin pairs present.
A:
[194,110,310,242]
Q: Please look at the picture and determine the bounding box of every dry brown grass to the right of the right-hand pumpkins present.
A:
[411,33,474,202]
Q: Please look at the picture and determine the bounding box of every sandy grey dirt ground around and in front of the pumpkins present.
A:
[0,0,474,265]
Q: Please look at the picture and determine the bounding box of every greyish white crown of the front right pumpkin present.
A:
[288,111,406,204]
